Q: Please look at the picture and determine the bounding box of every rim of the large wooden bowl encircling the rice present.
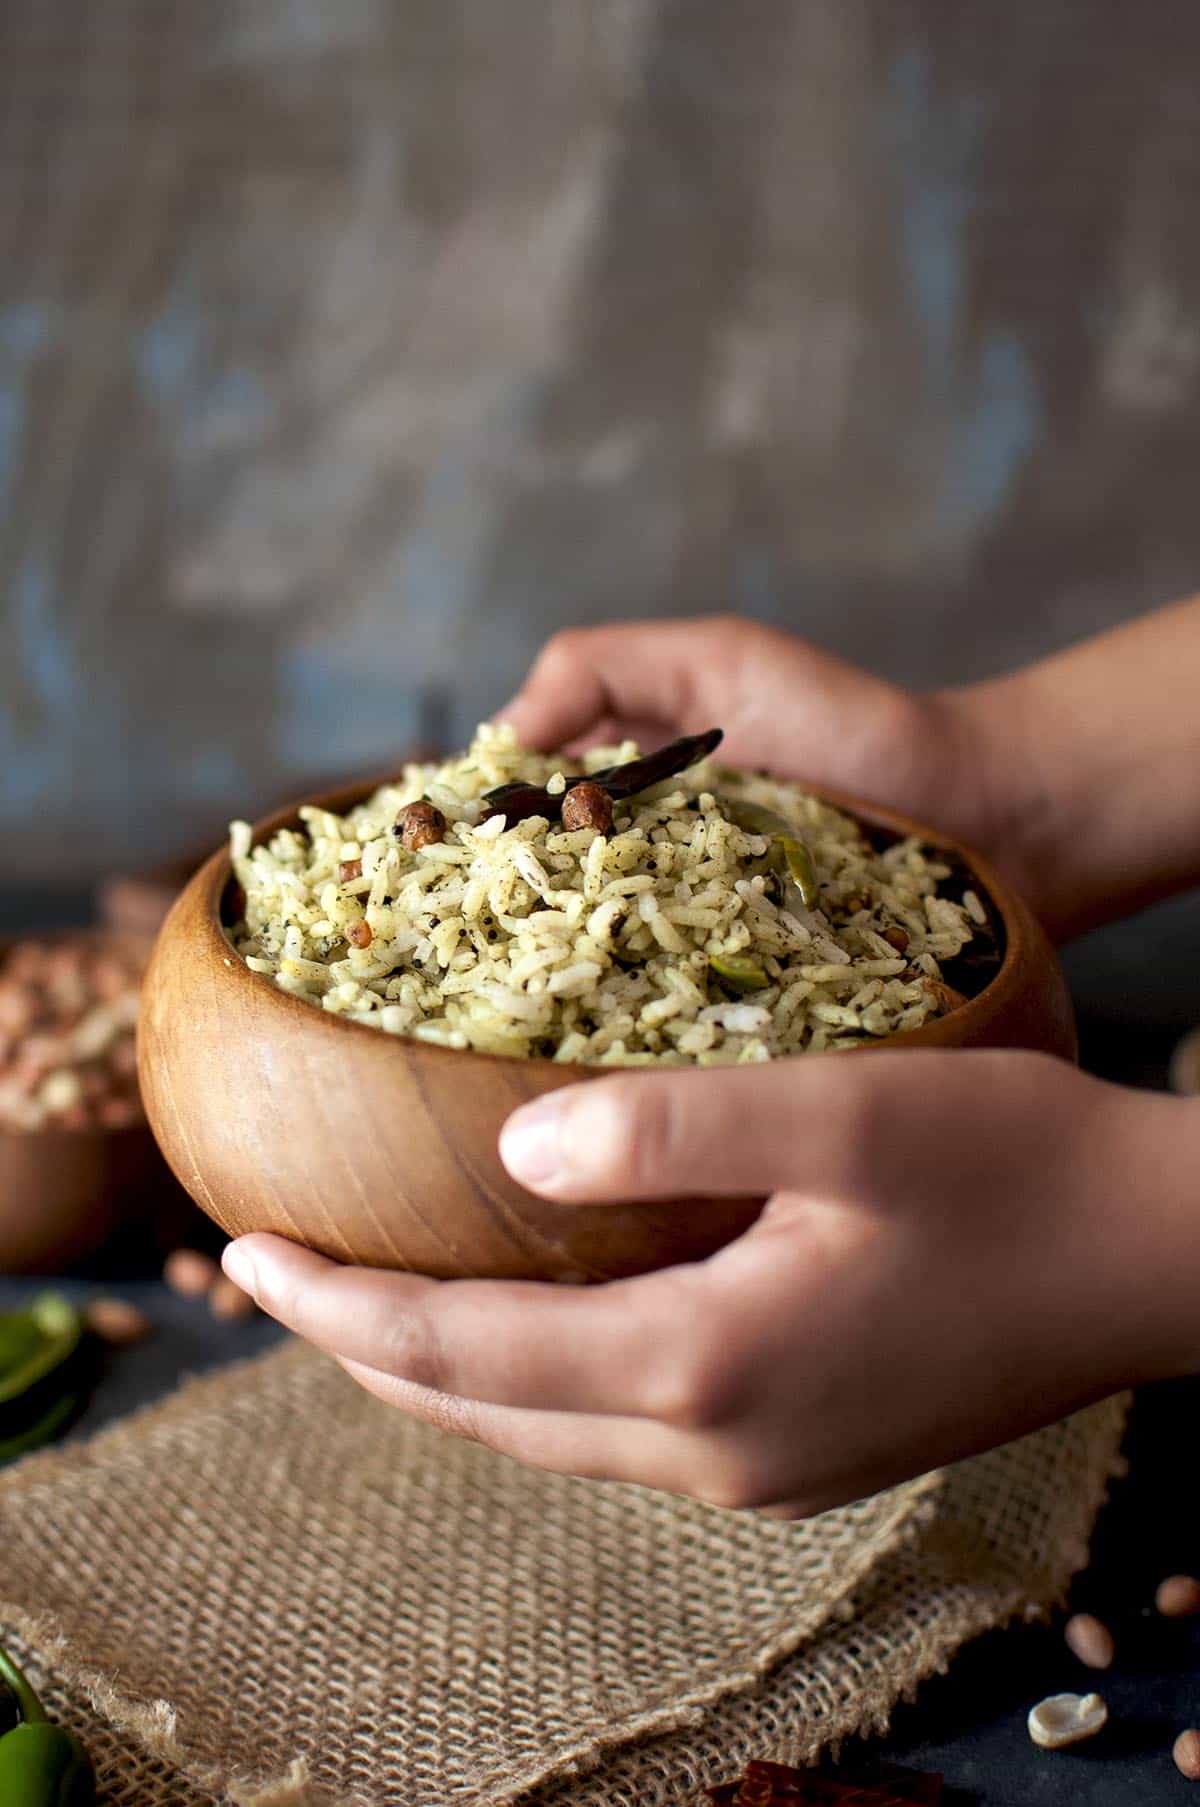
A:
[178,772,1041,1081]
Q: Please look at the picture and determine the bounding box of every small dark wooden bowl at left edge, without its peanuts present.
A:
[0,929,173,1274]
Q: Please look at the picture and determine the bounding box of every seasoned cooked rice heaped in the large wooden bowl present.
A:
[231,725,985,1066]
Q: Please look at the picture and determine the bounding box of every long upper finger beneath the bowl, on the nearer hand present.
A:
[224,1236,714,1417]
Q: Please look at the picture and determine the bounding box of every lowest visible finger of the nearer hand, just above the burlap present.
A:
[340,1359,740,1505]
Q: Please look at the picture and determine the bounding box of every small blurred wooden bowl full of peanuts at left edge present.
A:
[0,929,172,1274]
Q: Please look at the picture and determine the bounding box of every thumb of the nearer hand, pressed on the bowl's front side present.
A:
[501,1053,862,1202]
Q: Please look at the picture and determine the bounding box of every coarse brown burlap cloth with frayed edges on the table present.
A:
[0,1344,1124,1807]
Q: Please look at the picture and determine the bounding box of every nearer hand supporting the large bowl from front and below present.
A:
[217,1050,1198,1516]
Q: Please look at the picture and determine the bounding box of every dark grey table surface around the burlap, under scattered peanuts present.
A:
[0,889,1200,1807]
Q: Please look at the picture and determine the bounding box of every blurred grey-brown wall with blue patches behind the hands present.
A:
[0,0,1200,1035]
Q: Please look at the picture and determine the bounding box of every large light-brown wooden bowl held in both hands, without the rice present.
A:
[137,784,1075,1281]
